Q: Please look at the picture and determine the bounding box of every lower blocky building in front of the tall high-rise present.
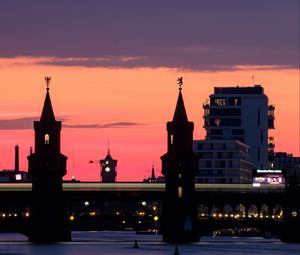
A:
[194,140,253,183]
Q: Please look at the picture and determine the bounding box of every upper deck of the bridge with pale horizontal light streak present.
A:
[0,182,285,207]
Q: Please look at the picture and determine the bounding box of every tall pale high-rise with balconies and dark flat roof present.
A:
[203,85,275,169]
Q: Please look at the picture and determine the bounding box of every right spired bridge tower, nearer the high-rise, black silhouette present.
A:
[161,78,198,243]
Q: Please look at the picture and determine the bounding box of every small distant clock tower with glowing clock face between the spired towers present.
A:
[100,148,118,183]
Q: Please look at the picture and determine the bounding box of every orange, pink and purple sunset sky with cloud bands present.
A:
[0,0,300,181]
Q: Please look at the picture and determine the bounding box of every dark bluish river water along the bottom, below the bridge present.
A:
[0,231,300,255]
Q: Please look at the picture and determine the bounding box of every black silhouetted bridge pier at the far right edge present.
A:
[280,174,300,243]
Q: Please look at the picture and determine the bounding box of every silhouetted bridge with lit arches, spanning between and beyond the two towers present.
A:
[0,182,294,240]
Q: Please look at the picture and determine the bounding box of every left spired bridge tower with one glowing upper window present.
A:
[28,77,71,242]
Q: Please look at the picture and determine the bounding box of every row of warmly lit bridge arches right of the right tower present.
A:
[197,203,284,237]
